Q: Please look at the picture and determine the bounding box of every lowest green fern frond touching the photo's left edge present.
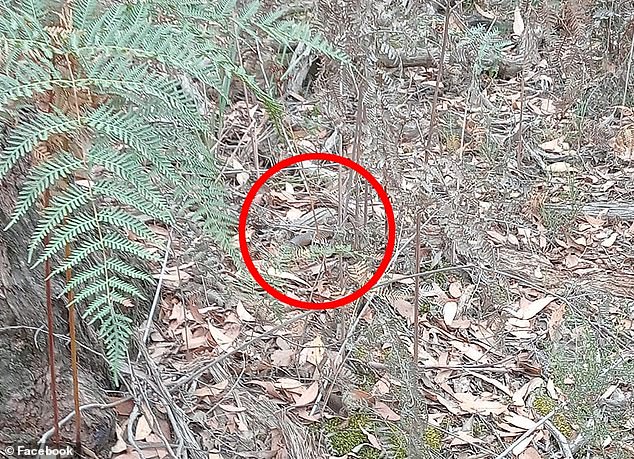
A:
[0,113,79,178]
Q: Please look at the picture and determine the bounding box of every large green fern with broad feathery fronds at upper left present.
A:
[0,0,341,374]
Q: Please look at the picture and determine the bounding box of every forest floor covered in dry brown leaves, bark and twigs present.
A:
[116,0,634,459]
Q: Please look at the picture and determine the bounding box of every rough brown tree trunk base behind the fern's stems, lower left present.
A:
[0,164,114,457]
